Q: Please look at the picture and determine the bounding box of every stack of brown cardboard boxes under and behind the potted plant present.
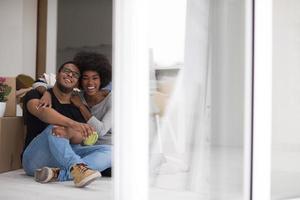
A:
[0,77,25,173]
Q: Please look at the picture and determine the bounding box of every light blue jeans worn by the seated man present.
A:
[22,125,111,181]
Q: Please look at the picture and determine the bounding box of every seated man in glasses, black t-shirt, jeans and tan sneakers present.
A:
[22,62,111,187]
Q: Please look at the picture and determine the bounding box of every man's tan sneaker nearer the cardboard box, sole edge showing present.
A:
[34,167,60,183]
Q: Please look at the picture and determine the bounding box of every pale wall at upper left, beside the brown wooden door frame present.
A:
[0,0,37,78]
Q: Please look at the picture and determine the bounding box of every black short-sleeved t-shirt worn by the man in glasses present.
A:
[23,89,86,150]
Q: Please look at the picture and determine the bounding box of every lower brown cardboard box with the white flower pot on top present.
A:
[0,117,25,173]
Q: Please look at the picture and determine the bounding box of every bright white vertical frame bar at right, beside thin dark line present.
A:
[252,0,272,200]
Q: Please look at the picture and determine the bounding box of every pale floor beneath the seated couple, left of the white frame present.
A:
[0,170,112,200]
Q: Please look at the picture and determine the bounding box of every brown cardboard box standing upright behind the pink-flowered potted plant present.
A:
[4,77,17,117]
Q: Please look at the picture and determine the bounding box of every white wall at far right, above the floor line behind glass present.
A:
[273,0,300,150]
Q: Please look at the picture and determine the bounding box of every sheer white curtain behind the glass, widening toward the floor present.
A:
[152,0,211,196]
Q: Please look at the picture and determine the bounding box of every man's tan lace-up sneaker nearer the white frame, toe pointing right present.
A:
[71,164,101,187]
